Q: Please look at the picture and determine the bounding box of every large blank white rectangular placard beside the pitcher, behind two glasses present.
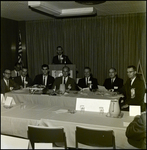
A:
[76,98,111,113]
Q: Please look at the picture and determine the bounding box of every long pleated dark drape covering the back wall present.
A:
[26,13,146,84]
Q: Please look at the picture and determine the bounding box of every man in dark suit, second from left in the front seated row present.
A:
[14,67,32,88]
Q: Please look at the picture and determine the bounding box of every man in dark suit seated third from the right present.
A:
[78,67,98,91]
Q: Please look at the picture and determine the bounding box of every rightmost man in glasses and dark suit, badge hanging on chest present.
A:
[118,65,145,111]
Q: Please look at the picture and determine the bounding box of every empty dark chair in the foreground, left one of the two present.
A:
[28,125,67,149]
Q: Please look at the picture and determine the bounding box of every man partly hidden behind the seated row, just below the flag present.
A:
[11,63,21,79]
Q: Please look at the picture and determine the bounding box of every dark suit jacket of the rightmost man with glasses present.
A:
[118,77,145,111]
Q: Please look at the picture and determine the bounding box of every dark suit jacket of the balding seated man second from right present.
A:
[103,77,123,91]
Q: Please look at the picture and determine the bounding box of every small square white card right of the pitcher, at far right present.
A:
[129,105,141,116]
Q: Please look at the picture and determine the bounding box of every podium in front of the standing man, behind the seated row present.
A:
[49,64,76,80]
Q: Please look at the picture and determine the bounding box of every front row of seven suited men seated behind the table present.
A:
[1,64,145,110]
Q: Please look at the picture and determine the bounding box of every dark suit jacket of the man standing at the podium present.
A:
[52,55,72,64]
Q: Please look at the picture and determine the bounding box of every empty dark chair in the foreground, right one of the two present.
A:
[75,126,115,149]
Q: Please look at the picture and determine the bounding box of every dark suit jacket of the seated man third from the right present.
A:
[78,77,99,89]
